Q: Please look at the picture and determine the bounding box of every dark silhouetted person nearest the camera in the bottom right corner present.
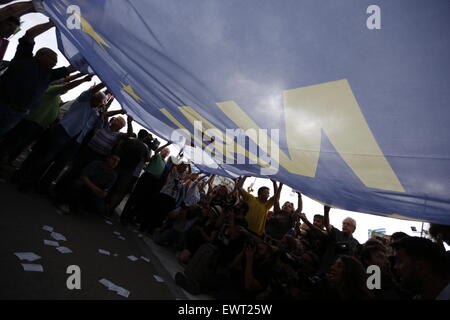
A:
[390,237,450,300]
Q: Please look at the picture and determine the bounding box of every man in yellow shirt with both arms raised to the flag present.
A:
[236,177,282,235]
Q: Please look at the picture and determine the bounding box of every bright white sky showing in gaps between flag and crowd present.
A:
[4,9,444,243]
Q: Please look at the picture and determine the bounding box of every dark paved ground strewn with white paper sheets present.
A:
[0,170,196,300]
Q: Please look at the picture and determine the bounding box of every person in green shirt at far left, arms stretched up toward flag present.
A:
[0,73,92,163]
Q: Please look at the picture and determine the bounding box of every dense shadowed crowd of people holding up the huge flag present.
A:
[0,1,450,300]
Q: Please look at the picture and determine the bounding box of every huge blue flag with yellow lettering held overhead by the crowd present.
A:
[34,0,450,224]
